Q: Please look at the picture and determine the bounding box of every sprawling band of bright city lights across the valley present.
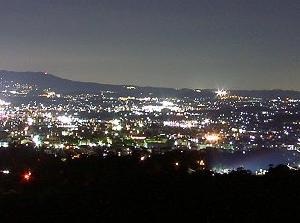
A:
[0,69,300,171]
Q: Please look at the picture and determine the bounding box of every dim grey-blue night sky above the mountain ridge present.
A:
[0,0,300,90]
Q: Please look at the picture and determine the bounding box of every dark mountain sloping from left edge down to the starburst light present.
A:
[0,70,213,97]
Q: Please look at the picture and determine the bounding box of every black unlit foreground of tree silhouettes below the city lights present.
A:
[0,148,300,222]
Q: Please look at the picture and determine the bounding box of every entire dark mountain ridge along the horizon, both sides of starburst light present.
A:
[0,70,300,98]
